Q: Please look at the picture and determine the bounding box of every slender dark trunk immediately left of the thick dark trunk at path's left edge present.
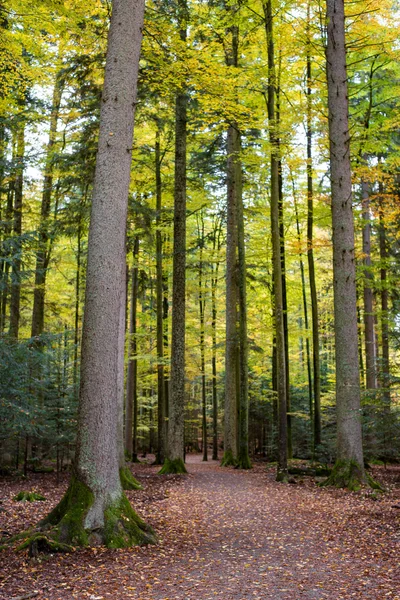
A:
[155,128,166,465]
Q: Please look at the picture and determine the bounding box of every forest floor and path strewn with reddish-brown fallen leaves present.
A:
[0,455,400,600]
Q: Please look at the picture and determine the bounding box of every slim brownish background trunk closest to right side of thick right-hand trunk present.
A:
[361,181,377,390]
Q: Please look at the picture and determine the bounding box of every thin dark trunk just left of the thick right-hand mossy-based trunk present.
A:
[307,2,321,450]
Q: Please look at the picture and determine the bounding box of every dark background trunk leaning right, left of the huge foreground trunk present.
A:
[31,74,64,337]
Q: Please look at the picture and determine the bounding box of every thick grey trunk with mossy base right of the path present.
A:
[326,0,366,489]
